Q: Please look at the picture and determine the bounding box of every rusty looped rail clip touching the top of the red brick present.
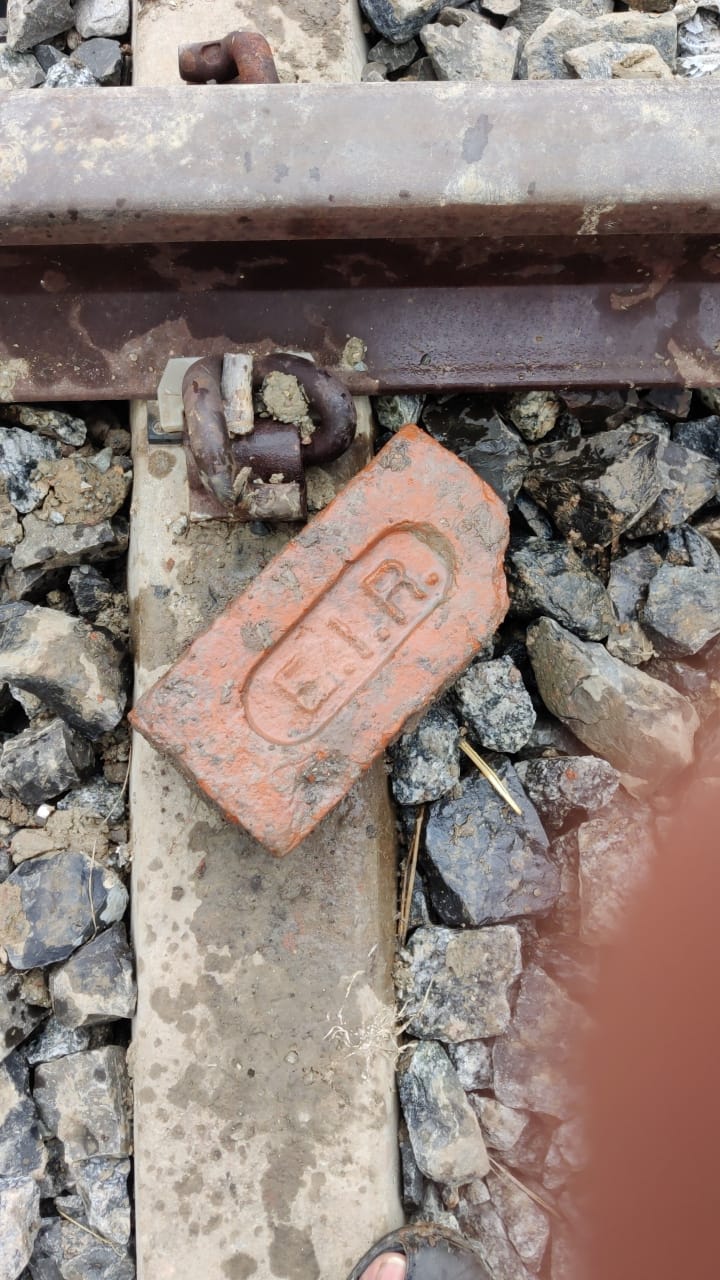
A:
[182,355,356,520]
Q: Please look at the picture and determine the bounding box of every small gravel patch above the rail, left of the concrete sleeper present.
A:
[0,0,132,90]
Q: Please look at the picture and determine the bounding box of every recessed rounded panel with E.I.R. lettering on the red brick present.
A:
[243,527,452,746]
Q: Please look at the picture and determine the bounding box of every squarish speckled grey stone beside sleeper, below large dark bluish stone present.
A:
[396,924,523,1043]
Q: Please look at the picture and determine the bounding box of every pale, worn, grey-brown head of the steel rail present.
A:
[0,79,720,246]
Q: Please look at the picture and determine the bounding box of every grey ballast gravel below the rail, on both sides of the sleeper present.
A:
[0,389,720,1280]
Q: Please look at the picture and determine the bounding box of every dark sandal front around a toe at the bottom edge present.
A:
[347,1222,491,1280]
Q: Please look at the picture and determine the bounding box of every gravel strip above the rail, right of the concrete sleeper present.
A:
[360,0,720,83]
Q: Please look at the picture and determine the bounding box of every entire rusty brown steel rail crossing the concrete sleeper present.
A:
[0,81,720,399]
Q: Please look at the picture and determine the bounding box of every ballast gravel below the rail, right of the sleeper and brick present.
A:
[375,389,720,1280]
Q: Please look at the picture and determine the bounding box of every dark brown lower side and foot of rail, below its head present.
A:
[0,237,720,399]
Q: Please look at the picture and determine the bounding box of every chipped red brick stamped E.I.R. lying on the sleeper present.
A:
[131,426,507,855]
